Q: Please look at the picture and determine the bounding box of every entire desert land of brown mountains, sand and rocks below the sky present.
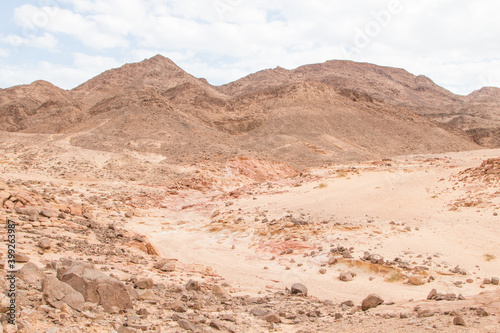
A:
[0,55,500,333]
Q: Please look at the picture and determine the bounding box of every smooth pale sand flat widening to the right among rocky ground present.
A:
[131,150,500,302]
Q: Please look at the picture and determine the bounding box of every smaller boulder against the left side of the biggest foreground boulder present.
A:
[42,276,85,311]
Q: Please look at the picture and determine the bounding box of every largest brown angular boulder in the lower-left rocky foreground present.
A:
[58,264,133,312]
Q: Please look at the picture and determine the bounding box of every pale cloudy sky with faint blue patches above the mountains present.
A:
[0,0,500,94]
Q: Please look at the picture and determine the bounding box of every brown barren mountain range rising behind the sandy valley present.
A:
[0,55,500,170]
